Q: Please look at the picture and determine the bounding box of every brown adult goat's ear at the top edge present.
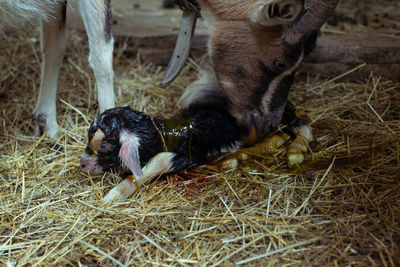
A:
[250,0,304,27]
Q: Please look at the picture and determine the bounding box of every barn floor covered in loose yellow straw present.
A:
[0,1,400,266]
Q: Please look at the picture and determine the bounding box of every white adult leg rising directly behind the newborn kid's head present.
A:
[79,0,115,112]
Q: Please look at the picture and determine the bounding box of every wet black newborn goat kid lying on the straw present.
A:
[81,97,311,202]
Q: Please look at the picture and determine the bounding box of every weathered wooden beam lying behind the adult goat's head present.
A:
[139,32,400,80]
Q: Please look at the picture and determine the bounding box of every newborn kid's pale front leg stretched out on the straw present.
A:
[103,152,176,202]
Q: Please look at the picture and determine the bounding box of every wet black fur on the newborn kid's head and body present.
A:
[85,101,248,176]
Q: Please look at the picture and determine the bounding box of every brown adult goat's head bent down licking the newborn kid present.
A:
[176,0,338,141]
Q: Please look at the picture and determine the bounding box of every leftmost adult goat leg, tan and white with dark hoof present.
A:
[32,3,66,137]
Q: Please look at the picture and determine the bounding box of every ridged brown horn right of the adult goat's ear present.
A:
[294,0,339,34]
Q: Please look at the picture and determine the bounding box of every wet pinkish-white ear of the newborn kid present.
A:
[119,131,143,178]
